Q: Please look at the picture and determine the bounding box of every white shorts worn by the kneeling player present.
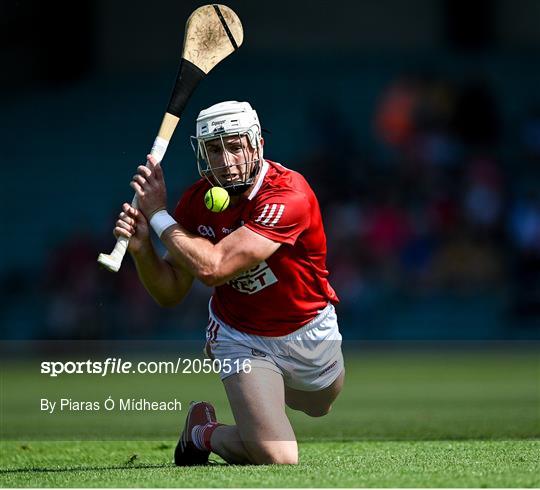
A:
[205,303,343,391]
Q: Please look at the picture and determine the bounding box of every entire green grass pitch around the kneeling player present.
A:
[0,350,540,487]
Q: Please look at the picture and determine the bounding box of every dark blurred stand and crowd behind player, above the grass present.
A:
[0,0,540,340]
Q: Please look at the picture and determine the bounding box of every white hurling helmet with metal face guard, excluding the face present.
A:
[191,100,262,195]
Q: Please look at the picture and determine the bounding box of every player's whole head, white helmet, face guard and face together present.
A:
[191,100,262,196]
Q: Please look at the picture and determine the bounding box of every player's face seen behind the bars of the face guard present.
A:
[205,135,259,187]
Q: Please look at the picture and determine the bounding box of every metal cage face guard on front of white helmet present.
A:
[191,131,262,196]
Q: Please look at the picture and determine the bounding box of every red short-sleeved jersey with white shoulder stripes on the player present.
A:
[174,160,339,337]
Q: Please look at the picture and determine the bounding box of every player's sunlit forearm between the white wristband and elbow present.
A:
[161,225,223,286]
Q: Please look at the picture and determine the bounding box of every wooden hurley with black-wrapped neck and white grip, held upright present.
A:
[98,4,244,272]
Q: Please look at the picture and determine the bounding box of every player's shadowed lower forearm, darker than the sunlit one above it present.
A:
[132,245,192,306]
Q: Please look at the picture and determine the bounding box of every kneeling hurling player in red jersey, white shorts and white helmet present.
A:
[114,101,344,465]
